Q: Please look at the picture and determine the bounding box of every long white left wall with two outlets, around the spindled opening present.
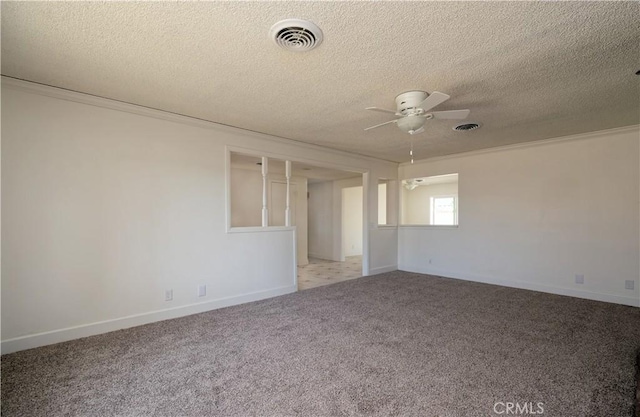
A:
[1,79,397,353]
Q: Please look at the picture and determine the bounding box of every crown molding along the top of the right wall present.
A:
[399,125,640,168]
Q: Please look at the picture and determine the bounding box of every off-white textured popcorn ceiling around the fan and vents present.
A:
[1,2,640,161]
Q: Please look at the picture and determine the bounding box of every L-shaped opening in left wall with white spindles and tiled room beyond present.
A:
[227,150,367,290]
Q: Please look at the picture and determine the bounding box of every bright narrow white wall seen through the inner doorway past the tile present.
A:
[342,186,363,256]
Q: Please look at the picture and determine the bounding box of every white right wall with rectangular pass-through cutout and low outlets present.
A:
[398,127,640,305]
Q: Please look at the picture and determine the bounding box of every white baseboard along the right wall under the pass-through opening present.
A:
[398,264,640,307]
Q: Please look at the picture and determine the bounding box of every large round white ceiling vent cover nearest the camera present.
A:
[269,19,322,52]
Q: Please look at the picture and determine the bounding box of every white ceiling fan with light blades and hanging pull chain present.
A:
[365,91,471,135]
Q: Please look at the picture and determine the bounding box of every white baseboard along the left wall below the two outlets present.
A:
[0,285,298,354]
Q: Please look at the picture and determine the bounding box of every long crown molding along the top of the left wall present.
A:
[2,75,398,167]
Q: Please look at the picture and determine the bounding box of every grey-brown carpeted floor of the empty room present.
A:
[2,272,640,417]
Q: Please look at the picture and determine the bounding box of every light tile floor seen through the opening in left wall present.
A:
[298,256,362,290]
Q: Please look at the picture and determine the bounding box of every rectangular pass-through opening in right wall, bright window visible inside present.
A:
[400,174,458,226]
